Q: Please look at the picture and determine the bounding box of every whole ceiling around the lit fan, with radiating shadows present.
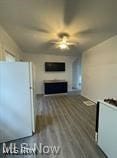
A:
[0,0,117,55]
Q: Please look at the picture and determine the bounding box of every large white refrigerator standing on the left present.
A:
[0,62,35,143]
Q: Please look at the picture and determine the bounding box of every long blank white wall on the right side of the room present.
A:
[82,36,117,101]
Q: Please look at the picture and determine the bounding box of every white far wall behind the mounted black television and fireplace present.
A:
[24,54,75,94]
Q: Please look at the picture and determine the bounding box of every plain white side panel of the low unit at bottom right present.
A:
[98,103,117,158]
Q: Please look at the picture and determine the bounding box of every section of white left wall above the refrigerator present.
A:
[0,26,21,60]
